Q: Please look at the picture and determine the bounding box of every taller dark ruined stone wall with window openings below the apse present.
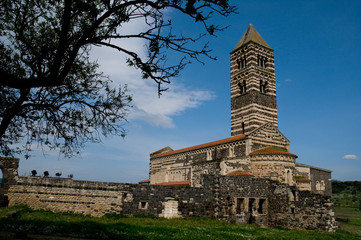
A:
[214,176,337,231]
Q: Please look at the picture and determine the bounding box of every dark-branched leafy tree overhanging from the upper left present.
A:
[0,0,236,157]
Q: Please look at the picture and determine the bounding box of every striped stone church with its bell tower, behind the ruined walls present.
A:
[149,24,332,196]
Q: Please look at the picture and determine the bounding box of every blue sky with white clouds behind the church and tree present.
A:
[11,0,361,183]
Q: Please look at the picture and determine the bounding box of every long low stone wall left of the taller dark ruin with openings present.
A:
[7,177,213,216]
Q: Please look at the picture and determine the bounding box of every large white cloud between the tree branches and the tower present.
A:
[92,18,214,128]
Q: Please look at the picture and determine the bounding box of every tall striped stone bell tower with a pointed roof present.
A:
[231,24,278,136]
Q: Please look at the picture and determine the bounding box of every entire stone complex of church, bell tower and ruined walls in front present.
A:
[0,25,336,231]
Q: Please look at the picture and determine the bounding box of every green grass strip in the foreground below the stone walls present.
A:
[0,206,361,240]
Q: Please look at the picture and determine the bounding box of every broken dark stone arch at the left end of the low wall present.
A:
[0,157,19,207]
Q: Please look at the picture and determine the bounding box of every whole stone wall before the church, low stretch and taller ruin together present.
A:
[7,175,336,231]
